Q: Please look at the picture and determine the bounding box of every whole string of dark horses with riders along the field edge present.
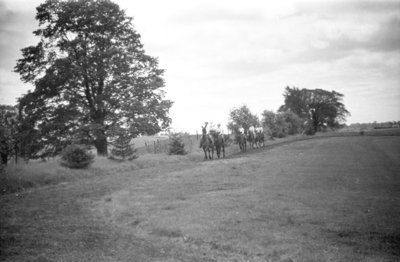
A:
[200,127,264,160]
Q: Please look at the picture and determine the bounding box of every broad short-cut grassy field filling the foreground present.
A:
[0,135,400,262]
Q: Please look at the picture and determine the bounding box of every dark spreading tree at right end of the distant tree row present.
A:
[279,87,350,133]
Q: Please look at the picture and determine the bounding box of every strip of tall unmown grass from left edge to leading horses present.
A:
[0,149,203,194]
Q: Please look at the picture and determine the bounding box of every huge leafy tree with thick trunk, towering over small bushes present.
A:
[15,0,172,155]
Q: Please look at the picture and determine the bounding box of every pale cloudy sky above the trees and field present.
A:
[0,0,400,133]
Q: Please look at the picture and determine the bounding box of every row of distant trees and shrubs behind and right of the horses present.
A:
[228,87,350,137]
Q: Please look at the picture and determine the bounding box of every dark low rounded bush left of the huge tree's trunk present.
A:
[61,144,94,168]
